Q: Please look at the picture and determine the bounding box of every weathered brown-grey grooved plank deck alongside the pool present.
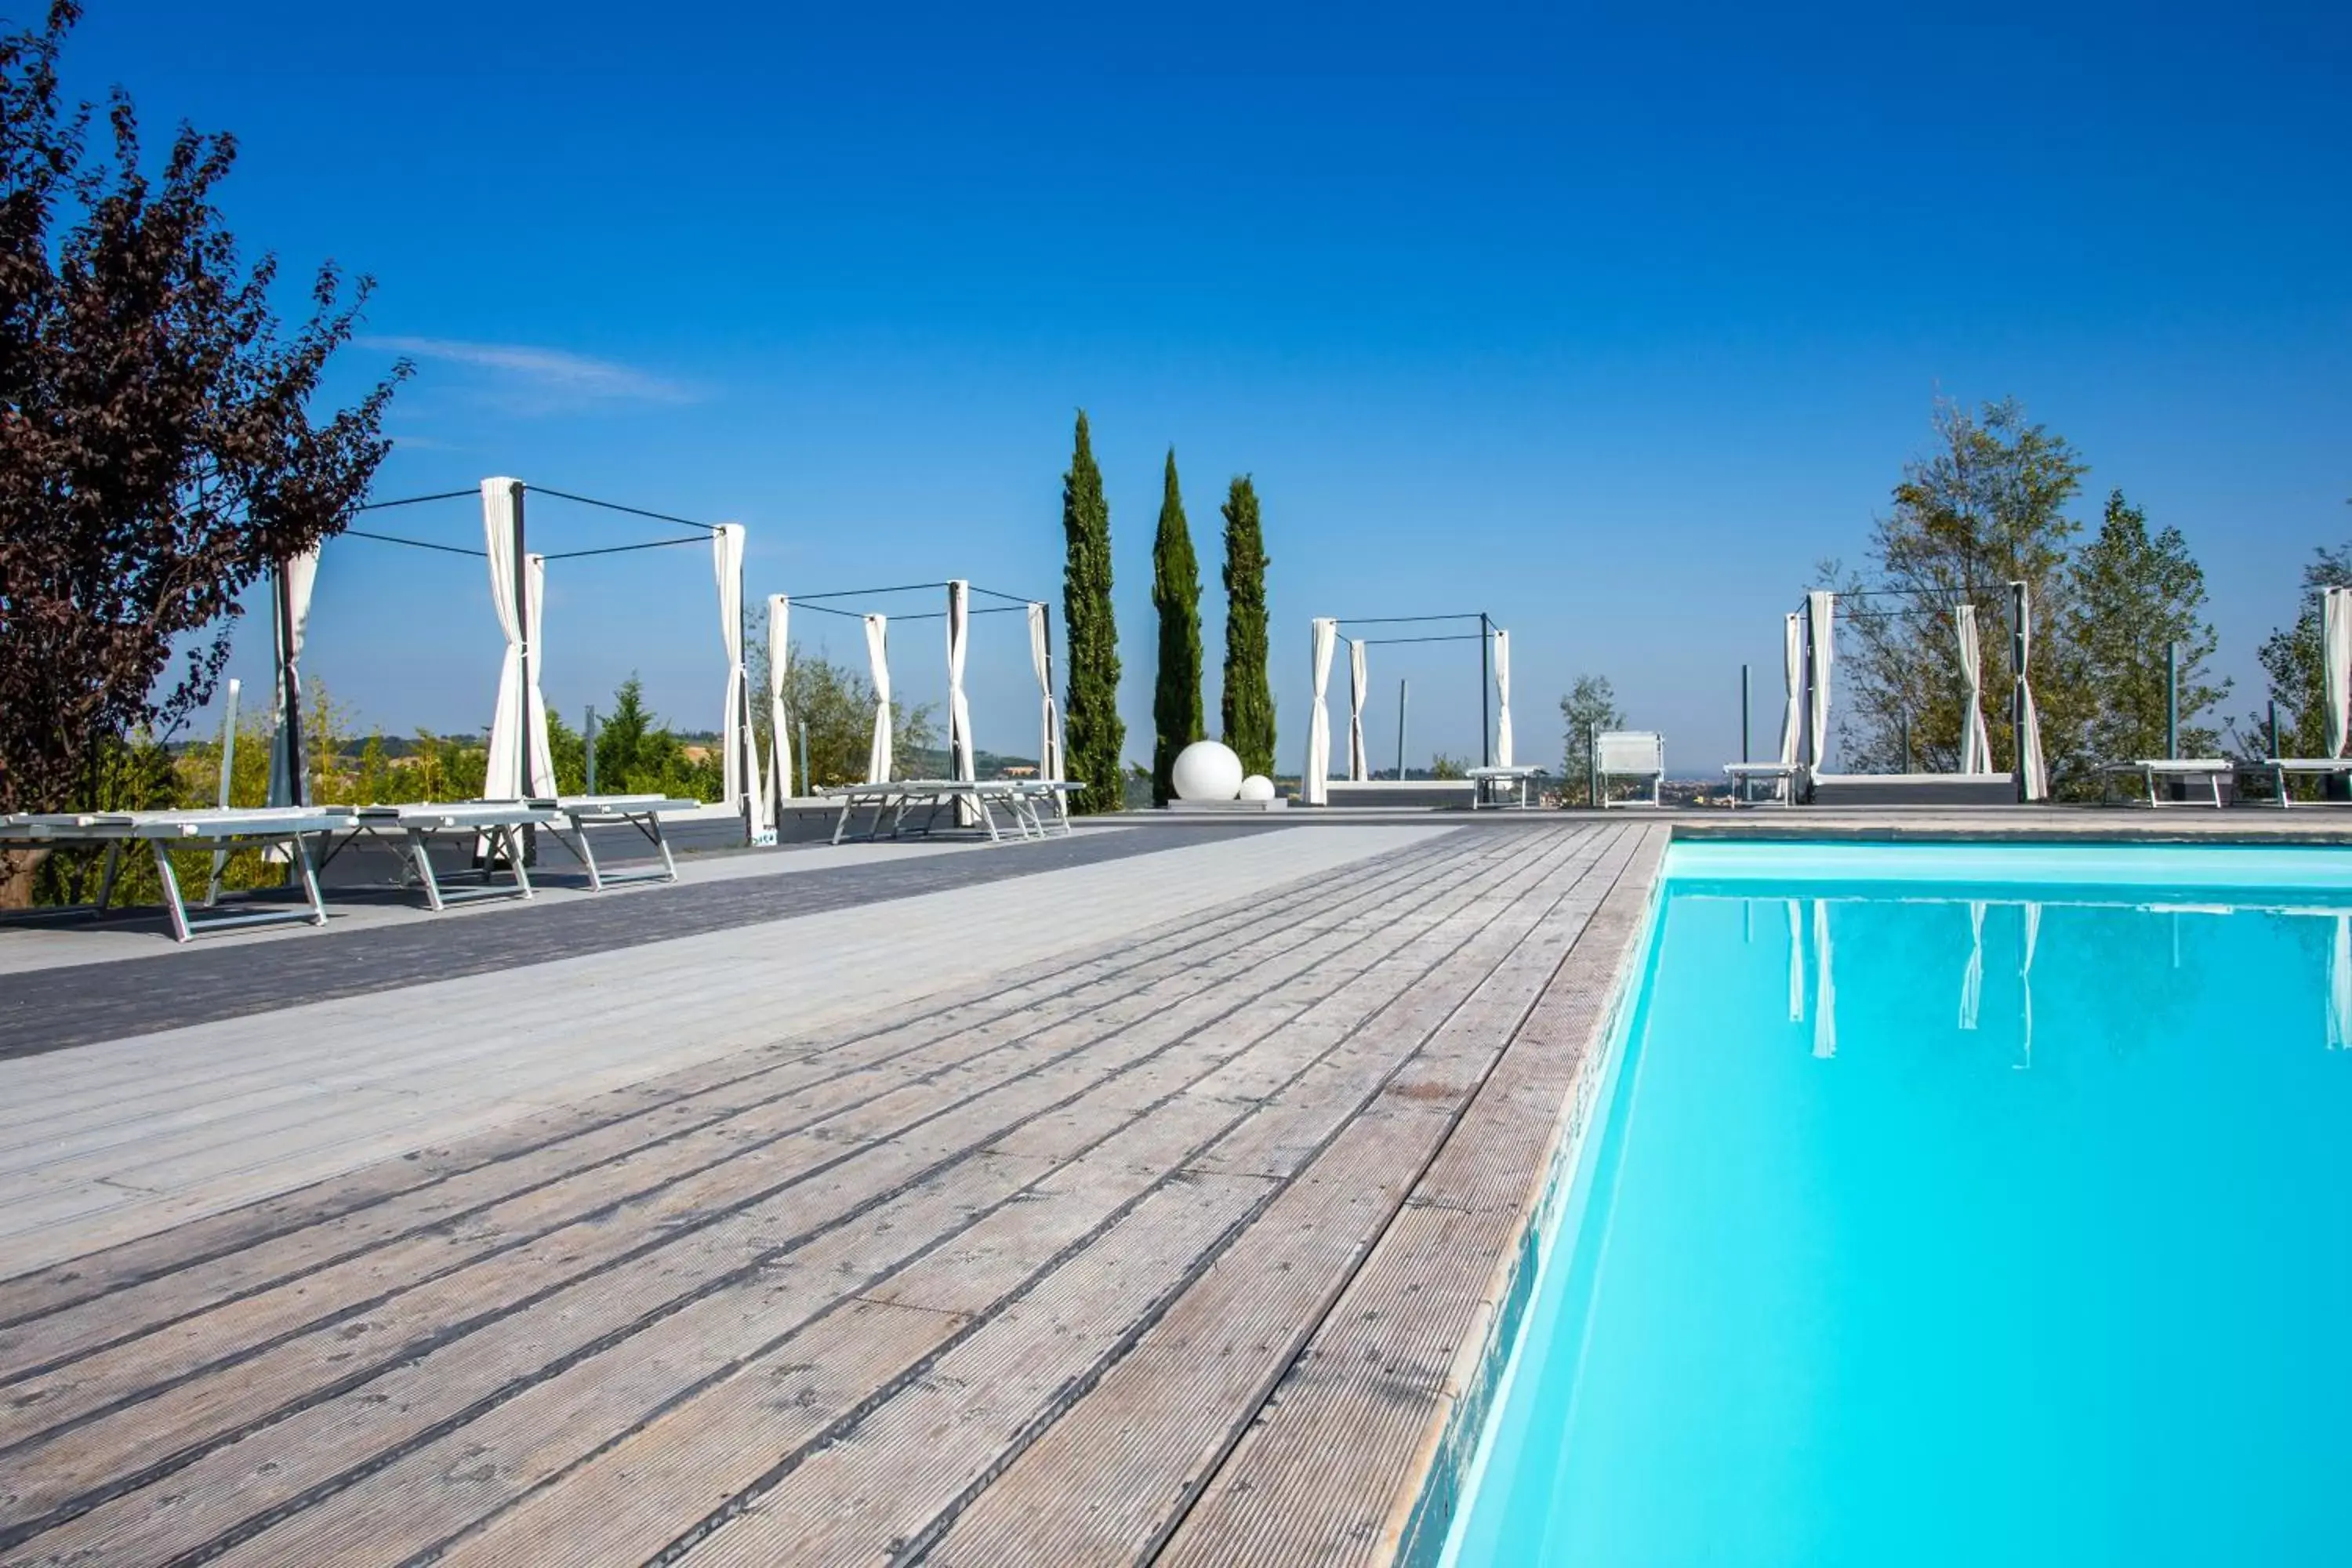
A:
[0,818,1668,1568]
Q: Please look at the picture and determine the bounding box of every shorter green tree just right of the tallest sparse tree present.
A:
[2063,492,2230,762]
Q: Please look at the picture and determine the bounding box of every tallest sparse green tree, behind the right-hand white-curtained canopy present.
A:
[1823,400,2096,781]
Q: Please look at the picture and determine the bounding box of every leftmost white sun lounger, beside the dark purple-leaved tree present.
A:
[0,806,353,942]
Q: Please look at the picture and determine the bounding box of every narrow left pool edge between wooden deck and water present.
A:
[1371,834,1670,1568]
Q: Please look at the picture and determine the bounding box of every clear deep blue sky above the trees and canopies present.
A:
[71,0,2352,771]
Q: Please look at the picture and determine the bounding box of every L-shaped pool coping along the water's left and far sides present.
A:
[1371,811,2352,1568]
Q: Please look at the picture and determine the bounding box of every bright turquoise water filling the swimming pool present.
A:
[1446,844,2352,1568]
